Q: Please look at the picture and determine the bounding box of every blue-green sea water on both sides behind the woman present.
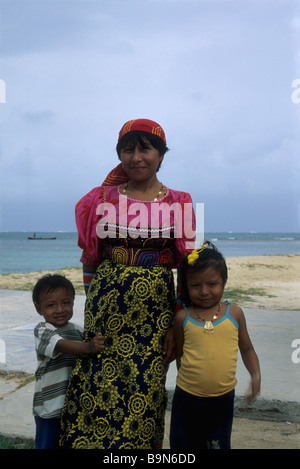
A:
[0,232,300,274]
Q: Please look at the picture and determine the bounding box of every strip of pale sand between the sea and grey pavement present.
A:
[0,254,300,311]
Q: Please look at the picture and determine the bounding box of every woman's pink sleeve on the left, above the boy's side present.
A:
[75,186,103,266]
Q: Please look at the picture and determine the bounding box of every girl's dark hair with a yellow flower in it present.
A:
[179,241,228,306]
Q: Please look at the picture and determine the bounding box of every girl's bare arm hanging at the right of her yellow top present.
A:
[238,308,261,402]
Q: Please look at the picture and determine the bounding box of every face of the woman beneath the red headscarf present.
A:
[120,145,164,182]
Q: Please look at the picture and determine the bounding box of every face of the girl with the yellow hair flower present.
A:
[187,267,225,309]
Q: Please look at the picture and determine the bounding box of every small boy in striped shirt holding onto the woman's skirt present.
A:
[32,274,104,449]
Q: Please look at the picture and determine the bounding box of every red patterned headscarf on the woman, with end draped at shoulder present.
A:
[102,119,167,186]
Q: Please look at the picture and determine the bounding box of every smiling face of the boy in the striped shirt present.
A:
[35,288,74,327]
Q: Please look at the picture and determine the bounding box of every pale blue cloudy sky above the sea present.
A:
[0,0,300,232]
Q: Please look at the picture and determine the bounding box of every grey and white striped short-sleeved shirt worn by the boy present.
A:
[33,322,83,418]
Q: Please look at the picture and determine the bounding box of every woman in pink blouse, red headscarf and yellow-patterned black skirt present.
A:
[61,119,195,449]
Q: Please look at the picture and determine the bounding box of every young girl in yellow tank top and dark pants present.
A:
[170,242,260,449]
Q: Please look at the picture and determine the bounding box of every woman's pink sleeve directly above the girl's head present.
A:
[174,188,196,268]
